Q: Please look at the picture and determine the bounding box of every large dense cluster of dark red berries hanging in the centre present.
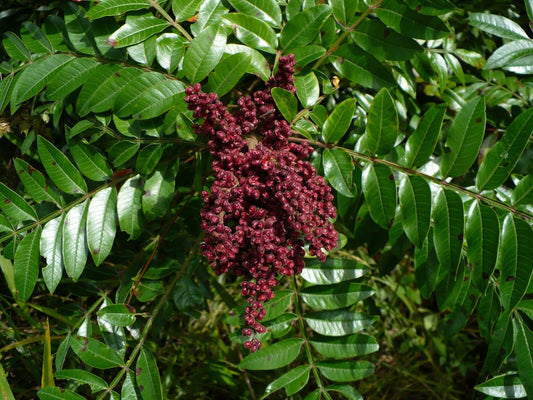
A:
[185,55,337,351]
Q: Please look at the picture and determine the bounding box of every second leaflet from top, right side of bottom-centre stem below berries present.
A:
[300,282,374,310]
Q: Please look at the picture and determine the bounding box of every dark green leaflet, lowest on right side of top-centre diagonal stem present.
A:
[332,45,396,89]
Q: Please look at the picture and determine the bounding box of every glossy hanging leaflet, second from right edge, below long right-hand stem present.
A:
[465,202,500,292]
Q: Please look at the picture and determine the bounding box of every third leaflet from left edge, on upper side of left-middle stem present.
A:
[37,136,87,194]
